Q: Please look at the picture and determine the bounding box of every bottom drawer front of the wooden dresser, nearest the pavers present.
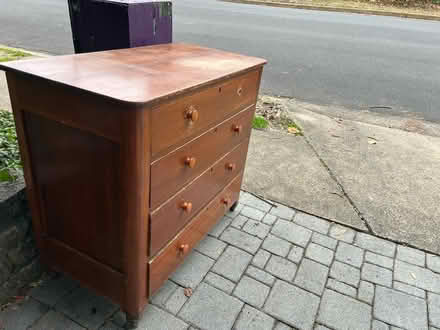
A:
[147,173,243,297]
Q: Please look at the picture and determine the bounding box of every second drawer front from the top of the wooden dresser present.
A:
[150,106,255,210]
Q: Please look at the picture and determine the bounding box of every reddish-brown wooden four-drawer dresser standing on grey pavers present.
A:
[0,44,265,325]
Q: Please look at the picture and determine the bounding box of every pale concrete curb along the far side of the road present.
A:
[219,0,440,21]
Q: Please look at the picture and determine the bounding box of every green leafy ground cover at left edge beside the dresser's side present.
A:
[0,110,22,182]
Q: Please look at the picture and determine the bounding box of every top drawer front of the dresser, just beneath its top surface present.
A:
[151,69,260,159]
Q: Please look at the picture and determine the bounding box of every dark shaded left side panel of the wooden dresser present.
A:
[7,72,125,303]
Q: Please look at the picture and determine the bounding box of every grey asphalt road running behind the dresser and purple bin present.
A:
[0,0,440,122]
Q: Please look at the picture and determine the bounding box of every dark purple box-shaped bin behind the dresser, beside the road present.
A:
[68,0,173,53]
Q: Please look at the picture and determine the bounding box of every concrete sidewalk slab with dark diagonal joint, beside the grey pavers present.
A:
[244,99,440,253]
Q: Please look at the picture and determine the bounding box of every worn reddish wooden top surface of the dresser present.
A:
[0,44,266,104]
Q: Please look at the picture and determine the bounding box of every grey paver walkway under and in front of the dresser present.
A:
[0,193,440,330]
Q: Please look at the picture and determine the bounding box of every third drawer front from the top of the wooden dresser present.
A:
[149,139,249,256]
